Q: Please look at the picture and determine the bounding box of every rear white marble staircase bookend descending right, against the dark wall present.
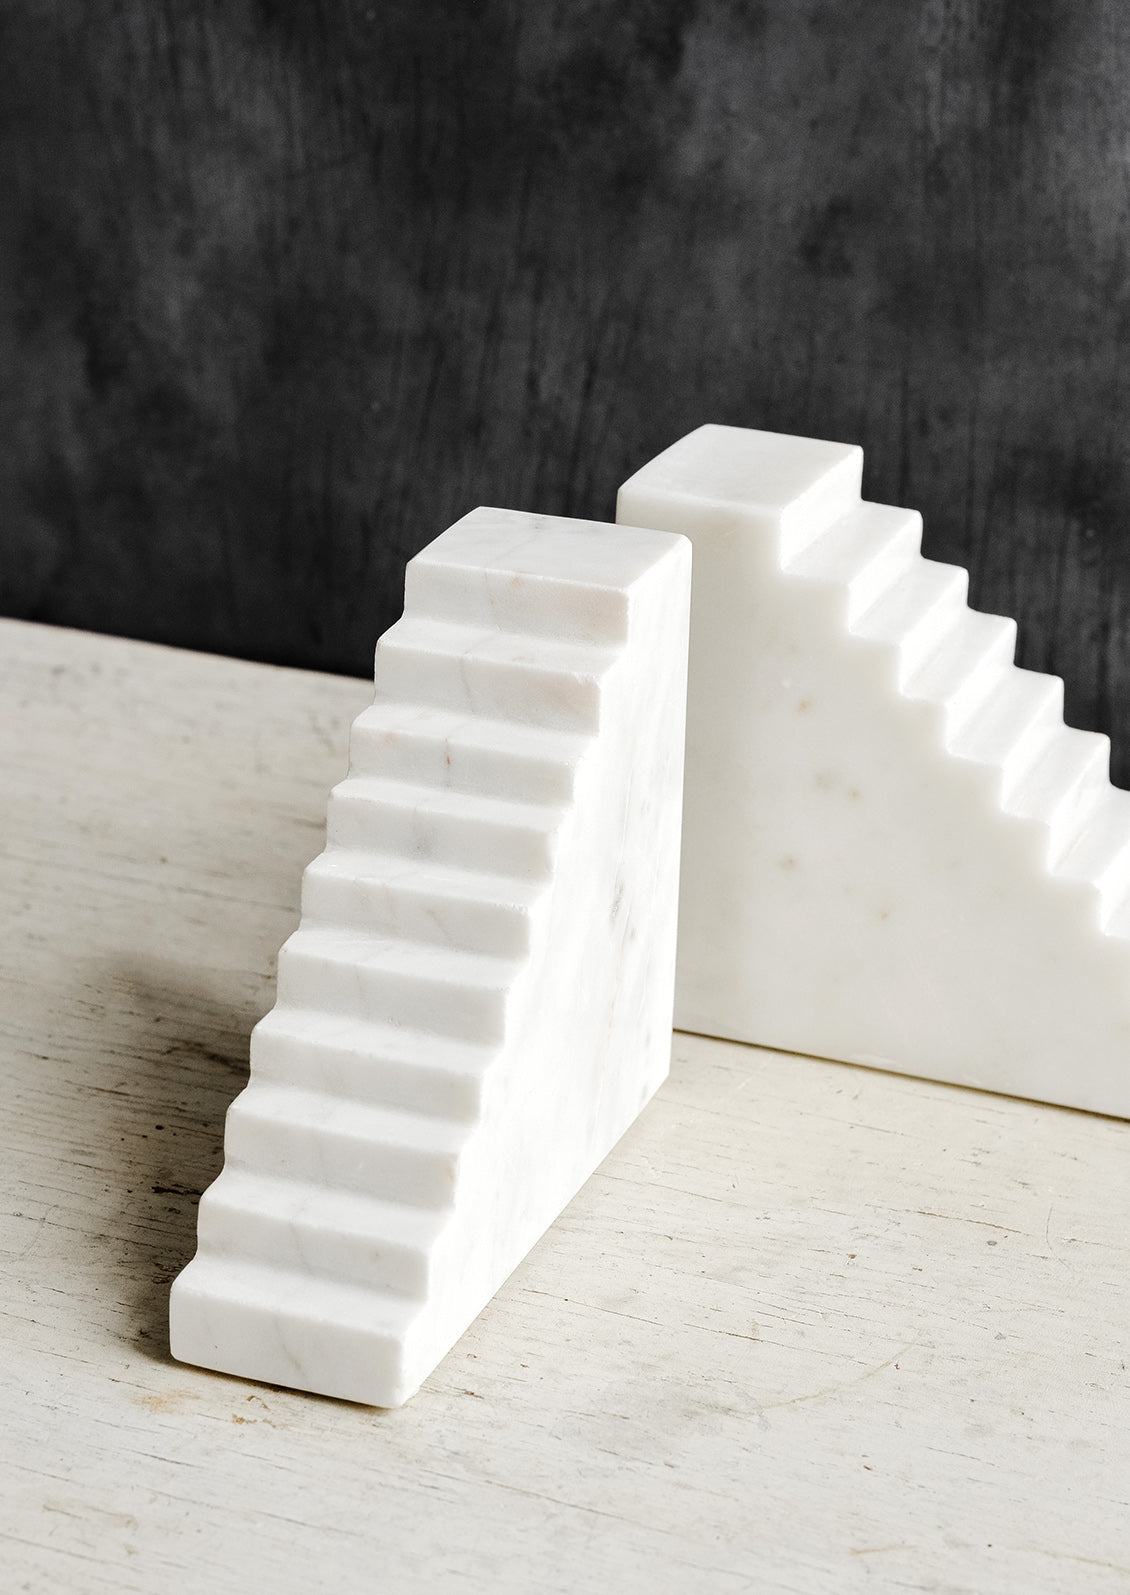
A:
[619,426,1130,1117]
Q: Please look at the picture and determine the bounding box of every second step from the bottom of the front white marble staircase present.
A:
[198,1168,447,1300]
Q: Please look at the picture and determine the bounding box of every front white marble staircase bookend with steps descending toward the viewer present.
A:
[171,509,689,1405]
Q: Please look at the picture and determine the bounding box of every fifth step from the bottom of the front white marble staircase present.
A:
[278,924,520,1045]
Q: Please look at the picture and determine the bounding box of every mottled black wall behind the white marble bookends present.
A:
[0,0,1130,780]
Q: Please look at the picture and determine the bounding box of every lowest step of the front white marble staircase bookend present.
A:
[169,1247,421,1405]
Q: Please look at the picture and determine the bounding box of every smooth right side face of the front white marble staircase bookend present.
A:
[405,539,689,1384]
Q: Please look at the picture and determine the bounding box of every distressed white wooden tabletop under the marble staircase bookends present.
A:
[0,622,1130,1595]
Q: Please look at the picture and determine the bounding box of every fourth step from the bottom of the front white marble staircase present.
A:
[251,1003,498,1123]
